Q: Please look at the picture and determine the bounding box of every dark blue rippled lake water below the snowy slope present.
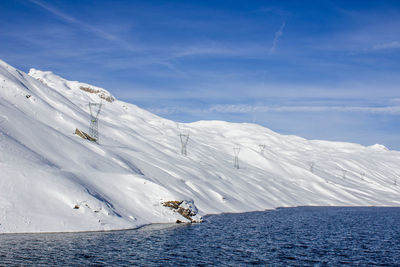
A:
[0,207,400,266]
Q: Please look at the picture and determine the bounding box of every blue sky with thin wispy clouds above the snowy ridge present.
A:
[0,0,400,150]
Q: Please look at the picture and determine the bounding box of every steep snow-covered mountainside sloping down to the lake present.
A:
[0,58,400,233]
